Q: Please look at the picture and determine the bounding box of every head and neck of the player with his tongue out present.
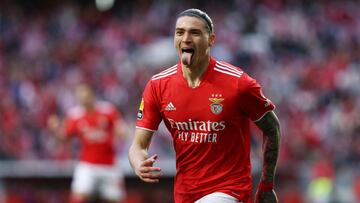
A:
[174,9,215,87]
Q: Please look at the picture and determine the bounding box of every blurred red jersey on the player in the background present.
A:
[65,102,121,165]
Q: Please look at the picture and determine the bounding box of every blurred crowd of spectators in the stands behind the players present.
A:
[0,0,360,203]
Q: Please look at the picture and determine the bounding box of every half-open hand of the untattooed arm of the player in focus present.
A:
[135,154,162,183]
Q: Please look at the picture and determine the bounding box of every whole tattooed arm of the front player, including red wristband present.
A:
[255,111,280,203]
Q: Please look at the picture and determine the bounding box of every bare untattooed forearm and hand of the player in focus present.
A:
[129,128,162,183]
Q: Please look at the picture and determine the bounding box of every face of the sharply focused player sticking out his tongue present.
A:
[174,16,215,68]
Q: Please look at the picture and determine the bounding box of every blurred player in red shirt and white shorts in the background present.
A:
[48,84,126,203]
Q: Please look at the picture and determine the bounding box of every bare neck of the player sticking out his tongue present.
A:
[181,57,210,87]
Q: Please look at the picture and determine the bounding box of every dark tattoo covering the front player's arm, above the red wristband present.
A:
[256,111,280,183]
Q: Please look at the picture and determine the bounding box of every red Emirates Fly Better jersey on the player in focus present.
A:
[136,59,275,203]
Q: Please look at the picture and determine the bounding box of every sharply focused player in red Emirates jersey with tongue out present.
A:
[129,9,280,203]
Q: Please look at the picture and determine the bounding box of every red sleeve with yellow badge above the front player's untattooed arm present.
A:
[136,80,161,131]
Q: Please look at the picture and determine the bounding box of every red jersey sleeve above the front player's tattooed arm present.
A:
[239,73,275,122]
